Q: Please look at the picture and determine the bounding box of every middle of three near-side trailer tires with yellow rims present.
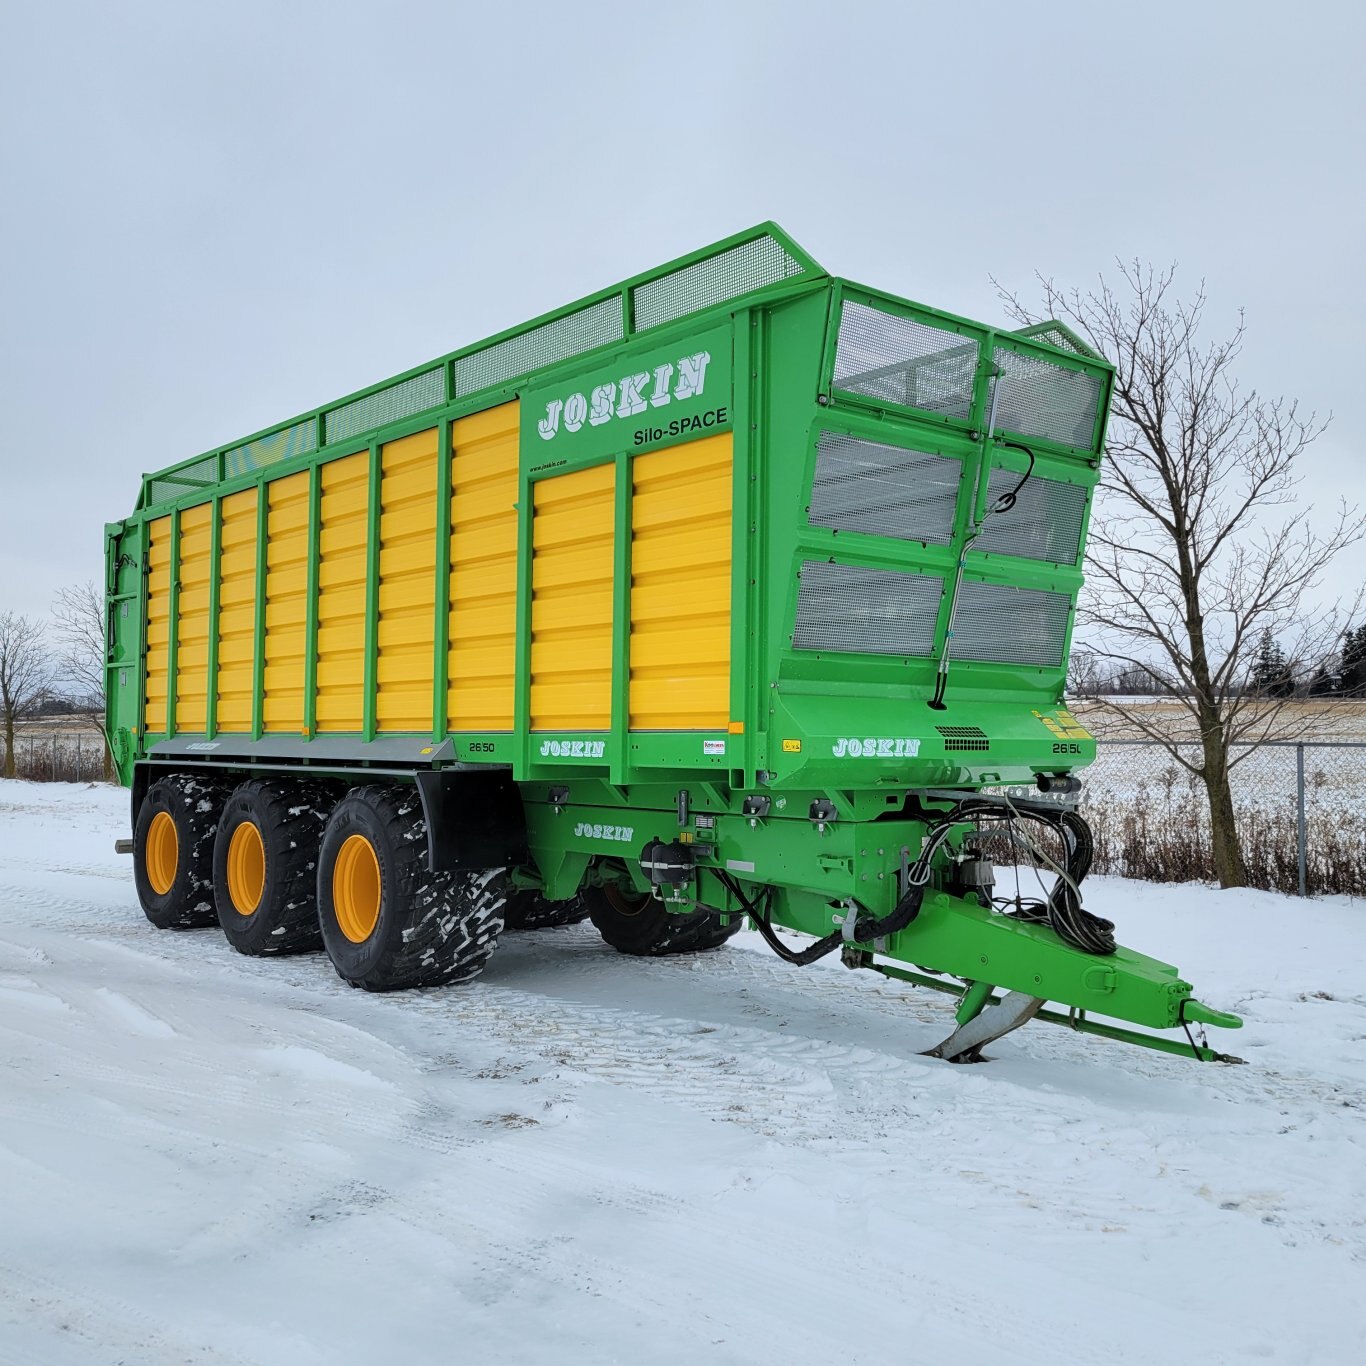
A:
[213,779,336,958]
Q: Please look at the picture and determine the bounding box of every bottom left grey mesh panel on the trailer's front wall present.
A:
[792,560,944,654]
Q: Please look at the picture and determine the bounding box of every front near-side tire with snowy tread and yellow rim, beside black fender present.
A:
[317,785,508,992]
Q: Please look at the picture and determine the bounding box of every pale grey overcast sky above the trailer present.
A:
[0,0,1366,625]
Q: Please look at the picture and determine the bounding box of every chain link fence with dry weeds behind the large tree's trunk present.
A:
[1081,740,1366,896]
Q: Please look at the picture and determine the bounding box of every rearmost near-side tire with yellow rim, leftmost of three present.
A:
[133,773,227,930]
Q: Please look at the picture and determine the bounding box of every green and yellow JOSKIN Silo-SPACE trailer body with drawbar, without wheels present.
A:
[105,224,1236,1057]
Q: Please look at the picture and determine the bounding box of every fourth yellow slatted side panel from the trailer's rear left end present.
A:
[260,470,309,735]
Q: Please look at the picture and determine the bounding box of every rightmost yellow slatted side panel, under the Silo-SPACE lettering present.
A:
[630,432,731,731]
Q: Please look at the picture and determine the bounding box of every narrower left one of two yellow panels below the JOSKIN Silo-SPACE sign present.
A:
[531,464,616,731]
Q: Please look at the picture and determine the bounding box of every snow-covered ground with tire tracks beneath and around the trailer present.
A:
[0,783,1366,1366]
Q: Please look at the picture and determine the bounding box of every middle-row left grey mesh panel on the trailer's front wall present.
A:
[810,432,963,545]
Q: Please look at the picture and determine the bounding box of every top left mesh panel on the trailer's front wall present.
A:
[835,301,979,418]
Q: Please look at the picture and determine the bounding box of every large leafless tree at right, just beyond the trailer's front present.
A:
[999,261,1366,887]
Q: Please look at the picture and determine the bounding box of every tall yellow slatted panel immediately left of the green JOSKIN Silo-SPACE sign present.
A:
[447,402,518,731]
